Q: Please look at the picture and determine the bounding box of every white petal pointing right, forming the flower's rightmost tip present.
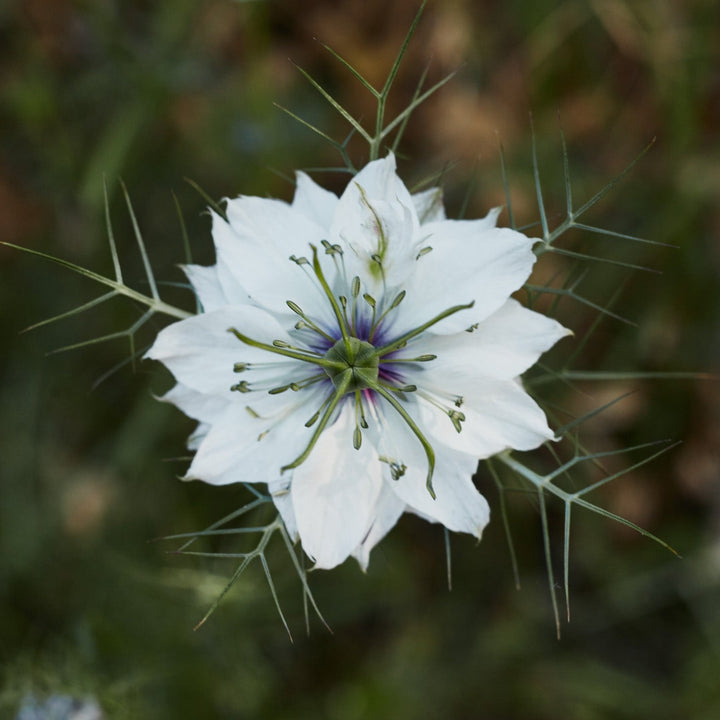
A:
[414,298,572,382]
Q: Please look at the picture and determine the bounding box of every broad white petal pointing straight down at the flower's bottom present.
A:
[291,401,383,569]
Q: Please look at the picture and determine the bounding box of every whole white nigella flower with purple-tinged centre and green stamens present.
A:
[148,155,568,568]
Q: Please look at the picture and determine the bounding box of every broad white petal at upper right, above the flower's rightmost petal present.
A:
[392,219,535,333]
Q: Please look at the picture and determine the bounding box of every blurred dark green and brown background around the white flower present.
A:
[0,0,720,720]
